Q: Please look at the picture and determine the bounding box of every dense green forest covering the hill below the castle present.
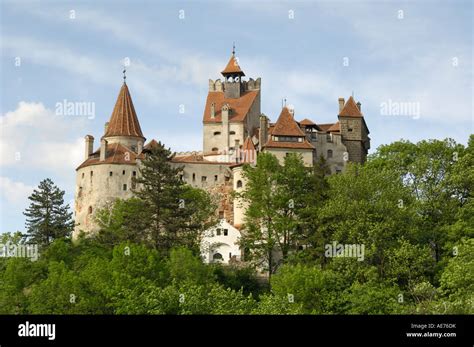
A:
[0,135,474,314]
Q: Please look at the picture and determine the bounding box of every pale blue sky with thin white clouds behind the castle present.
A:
[0,0,474,232]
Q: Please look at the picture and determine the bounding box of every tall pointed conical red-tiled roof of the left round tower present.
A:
[104,83,143,138]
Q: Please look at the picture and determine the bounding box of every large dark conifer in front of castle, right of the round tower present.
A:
[135,143,214,253]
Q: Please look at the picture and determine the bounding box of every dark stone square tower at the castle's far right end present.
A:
[338,96,370,163]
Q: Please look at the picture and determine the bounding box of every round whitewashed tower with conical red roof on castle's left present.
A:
[73,82,145,238]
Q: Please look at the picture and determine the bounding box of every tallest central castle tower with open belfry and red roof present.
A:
[203,48,261,162]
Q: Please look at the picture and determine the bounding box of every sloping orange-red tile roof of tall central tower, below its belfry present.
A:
[203,90,260,123]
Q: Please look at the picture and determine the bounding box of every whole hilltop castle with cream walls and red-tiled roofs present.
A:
[73,52,370,263]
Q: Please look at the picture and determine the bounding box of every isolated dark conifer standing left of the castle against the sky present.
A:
[23,178,74,246]
